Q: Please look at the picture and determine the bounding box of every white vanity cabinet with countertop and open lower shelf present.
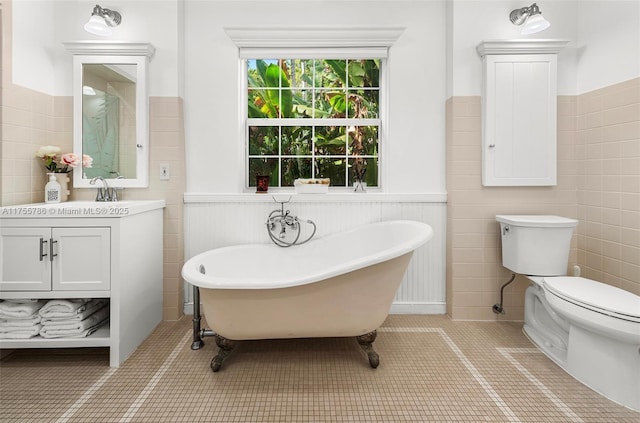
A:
[0,200,164,367]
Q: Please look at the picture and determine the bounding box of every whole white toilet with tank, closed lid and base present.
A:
[496,215,640,411]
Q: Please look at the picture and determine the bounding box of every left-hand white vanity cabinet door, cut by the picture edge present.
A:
[0,228,51,291]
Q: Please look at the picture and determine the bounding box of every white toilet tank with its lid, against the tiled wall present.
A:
[496,215,578,276]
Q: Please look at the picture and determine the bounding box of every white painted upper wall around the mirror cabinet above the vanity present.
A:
[12,0,181,96]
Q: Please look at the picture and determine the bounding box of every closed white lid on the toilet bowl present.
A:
[542,276,640,323]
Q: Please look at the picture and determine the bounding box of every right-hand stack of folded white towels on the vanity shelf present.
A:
[39,299,109,338]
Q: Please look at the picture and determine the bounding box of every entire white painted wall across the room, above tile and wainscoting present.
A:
[13,0,640,192]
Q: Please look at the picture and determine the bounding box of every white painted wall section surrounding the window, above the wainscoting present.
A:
[185,1,446,193]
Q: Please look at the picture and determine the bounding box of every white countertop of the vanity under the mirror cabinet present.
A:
[0,200,165,219]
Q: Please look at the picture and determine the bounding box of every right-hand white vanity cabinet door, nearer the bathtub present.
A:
[51,228,111,291]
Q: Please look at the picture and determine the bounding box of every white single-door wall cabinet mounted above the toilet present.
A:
[478,40,564,186]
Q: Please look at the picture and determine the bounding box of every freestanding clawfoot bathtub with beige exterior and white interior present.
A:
[182,221,433,371]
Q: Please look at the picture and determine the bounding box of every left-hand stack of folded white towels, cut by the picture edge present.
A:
[0,300,46,339]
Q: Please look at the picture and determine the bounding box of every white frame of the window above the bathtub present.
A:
[240,56,388,192]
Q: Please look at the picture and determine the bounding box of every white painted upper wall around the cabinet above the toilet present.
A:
[449,0,640,96]
